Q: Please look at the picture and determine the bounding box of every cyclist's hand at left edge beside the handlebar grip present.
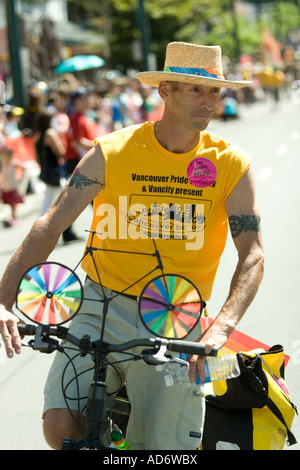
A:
[0,305,22,358]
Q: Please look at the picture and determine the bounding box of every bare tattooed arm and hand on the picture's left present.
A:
[0,145,104,357]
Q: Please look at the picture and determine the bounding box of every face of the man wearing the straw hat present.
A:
[163,82,220,131]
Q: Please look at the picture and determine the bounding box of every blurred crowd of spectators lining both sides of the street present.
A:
[0,56,294,229]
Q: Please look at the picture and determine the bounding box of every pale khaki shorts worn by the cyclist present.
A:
[44,280,205,450]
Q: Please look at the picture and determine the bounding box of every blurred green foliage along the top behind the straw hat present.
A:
[22,0,300,68]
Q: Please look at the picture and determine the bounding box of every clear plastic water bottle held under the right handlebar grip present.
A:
[165,352,241,387]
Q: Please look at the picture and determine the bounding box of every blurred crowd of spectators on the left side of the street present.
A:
[0,74,162,230]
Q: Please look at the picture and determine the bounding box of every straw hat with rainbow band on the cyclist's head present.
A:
[137,42,251,88]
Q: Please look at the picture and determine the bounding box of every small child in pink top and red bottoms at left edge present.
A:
[0,147,23,227]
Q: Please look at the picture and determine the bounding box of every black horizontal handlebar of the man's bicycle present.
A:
[18,323,218,356]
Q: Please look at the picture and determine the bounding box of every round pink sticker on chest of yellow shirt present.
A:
[187,157,217,188]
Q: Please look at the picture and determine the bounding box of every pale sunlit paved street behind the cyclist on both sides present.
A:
[0,93,300,450]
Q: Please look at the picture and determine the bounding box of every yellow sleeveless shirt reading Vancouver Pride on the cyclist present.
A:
[82,122,250,301]
